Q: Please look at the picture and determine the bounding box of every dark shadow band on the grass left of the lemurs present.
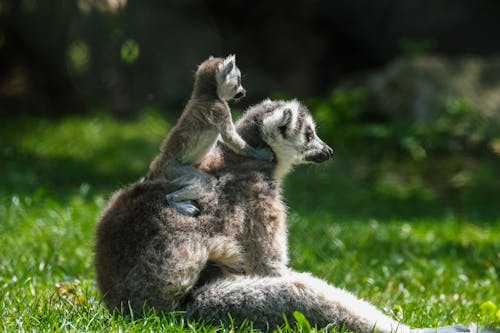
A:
[0,140,150,199]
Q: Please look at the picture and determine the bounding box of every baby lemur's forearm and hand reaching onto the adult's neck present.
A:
[217,114,274,162]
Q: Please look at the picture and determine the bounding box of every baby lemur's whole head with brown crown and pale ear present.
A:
[193,55,246,101]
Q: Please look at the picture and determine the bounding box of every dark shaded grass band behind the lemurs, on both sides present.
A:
[4,144,500,223]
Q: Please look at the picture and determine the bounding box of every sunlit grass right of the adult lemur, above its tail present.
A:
[290,211,500,326]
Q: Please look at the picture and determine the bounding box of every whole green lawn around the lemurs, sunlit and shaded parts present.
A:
[0,113,500,332]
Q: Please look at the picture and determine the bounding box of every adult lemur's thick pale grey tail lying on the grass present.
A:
[186,272,410,333]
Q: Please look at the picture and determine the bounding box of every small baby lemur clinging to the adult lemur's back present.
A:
[146,55,274,216]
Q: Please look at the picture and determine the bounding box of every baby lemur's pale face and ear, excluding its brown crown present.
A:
[216,55,246,101]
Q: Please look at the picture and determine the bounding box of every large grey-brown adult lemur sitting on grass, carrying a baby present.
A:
[96,101,466,333]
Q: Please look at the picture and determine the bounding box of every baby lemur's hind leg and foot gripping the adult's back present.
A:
[164,161,216,216]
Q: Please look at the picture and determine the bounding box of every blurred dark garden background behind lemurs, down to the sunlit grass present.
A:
[0,0,500,220]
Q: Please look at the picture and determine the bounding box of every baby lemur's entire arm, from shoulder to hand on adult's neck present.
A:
[212,103,274,161]
